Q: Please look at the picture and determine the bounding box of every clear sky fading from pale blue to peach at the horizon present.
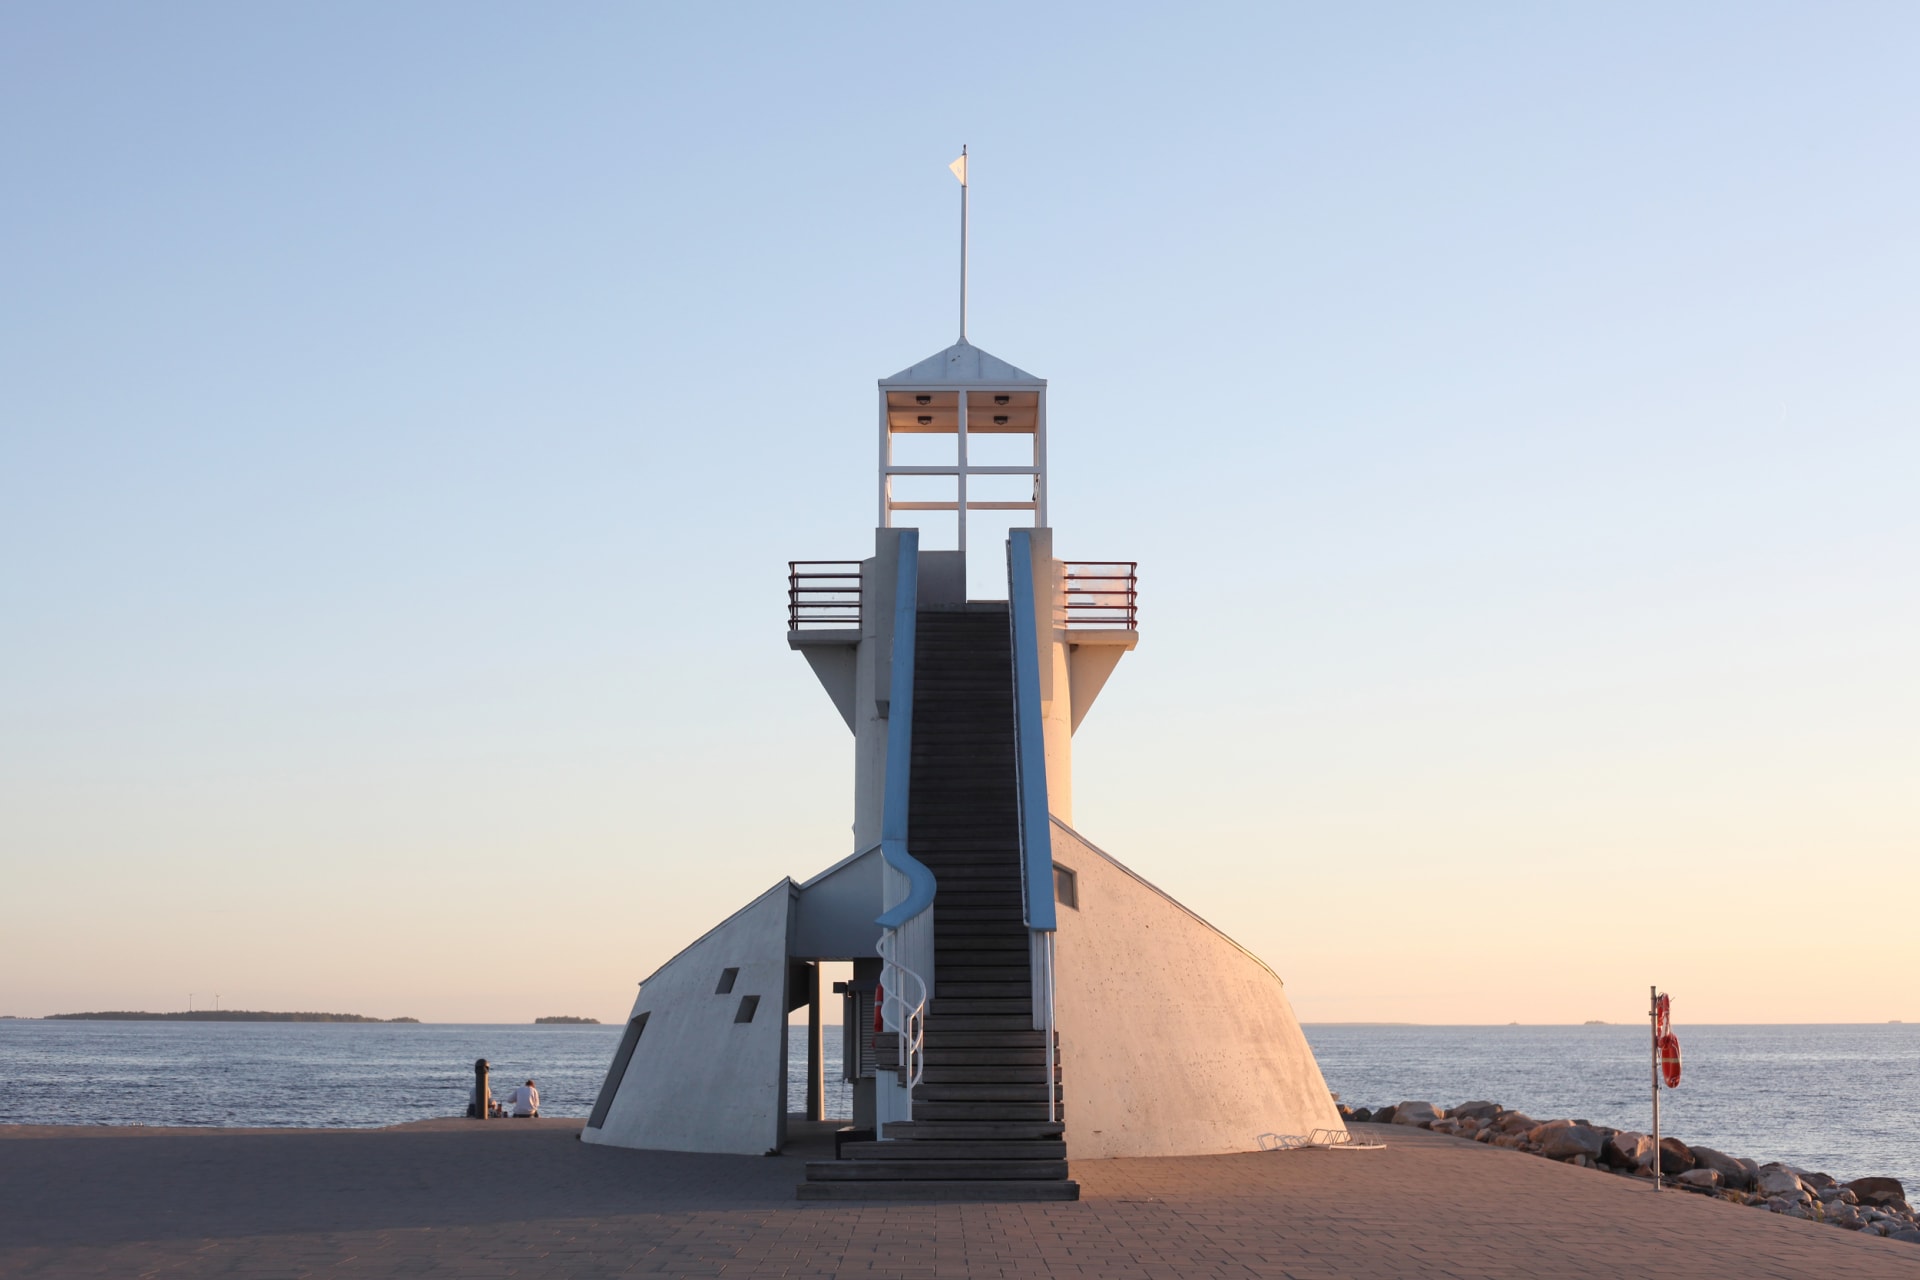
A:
[0,4,1920,1021]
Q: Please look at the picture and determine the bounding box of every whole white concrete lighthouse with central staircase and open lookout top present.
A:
[582,167,1340,1199]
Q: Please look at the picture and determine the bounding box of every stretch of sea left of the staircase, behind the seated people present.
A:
[0,1019,852,1128]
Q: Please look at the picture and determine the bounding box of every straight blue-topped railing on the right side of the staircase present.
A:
[1006,530,1058,1121]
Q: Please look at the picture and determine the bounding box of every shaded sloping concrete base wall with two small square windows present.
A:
[582,881,793,1155]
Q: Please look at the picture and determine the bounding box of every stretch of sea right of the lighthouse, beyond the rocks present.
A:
[1306,1025,1920,1190]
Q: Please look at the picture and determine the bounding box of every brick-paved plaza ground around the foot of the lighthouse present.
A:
[0,1121,1920,1280]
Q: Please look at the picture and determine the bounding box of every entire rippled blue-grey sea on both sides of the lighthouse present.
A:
[0,1019,1920,1190]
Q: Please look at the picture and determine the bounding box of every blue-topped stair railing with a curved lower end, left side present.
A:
[874,530,937,1121]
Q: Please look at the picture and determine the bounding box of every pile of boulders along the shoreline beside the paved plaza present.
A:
[1340,1102,1920,1244]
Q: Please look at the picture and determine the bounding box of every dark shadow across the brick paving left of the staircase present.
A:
[0,1123,833,1247]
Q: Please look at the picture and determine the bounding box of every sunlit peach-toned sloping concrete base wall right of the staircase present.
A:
[1054,821,1340,1159]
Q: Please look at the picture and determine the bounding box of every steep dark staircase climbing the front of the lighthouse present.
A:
[799,604,1079,1201]
